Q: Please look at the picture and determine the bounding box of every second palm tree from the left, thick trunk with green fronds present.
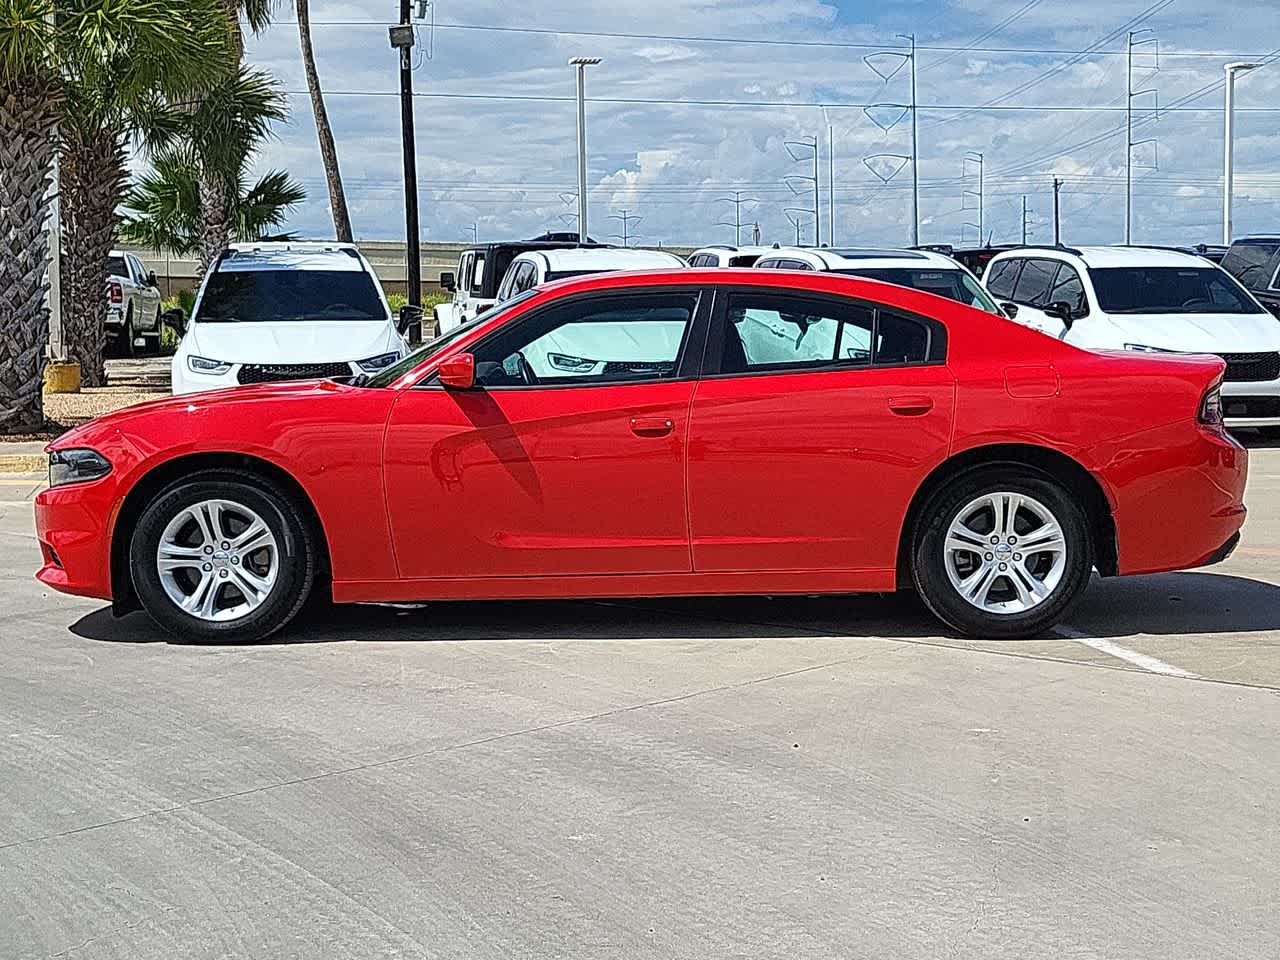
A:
[58,0,230,387]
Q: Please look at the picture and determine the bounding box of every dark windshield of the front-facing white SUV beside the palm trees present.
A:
[192,270,388,324]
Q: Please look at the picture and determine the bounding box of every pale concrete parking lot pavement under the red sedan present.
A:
[0,448,1280,960]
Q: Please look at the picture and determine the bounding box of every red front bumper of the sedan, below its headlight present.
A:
[36,476,118,600]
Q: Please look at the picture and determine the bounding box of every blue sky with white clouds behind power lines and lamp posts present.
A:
[230,0,1280,252]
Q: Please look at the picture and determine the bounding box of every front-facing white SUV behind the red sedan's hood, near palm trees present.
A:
[173,248,416,394]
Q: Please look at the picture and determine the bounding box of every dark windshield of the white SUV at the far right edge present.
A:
[1089,266,1262,314]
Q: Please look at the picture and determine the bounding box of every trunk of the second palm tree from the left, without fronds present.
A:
[58,128,127,387]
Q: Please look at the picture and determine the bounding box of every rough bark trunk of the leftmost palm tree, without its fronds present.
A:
[0,77,58,433]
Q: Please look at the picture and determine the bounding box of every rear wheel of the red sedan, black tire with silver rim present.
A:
[911,467,1093,640]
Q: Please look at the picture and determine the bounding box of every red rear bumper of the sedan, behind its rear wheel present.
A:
[1091,421,1248,573]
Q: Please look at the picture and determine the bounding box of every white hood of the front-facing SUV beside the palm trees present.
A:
[183,320,404,364]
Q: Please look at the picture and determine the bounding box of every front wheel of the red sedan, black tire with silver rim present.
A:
[129,470,316,644]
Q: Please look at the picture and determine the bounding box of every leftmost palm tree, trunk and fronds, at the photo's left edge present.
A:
[0,0,60,433]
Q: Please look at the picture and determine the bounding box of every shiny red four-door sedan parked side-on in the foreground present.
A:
[36,270,1247,641]
